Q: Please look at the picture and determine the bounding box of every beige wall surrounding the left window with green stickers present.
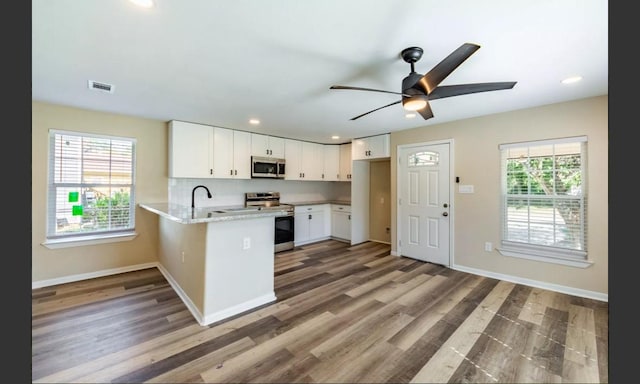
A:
[31,102,168,282]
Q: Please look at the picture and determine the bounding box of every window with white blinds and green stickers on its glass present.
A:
[47,130,136,239]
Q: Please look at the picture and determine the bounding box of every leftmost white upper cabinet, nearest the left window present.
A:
[169,120,213,178]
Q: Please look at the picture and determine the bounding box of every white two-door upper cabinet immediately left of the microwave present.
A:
[213,127,251,179]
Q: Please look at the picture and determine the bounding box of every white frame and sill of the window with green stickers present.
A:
[42,129,137,249]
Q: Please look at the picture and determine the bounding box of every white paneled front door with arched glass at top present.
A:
[398,143,451,267]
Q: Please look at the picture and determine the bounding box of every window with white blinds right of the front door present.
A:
[500,136,587,264]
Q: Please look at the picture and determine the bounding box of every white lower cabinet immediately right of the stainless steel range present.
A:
[294,204,331,246]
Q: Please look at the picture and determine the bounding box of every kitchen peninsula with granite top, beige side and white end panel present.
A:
[139,204,286,325]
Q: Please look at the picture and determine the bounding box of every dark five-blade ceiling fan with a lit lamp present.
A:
[329,43,516,120]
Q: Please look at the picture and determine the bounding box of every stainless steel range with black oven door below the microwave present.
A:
[244,192,295,252]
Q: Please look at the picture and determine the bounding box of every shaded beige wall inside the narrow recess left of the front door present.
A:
[369,160,395,243]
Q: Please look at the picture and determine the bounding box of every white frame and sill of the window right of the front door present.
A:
[497,136,593,268]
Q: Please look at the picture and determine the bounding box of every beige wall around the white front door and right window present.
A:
[391,96,609,295]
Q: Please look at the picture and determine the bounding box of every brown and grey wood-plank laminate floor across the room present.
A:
[32,240,609,383]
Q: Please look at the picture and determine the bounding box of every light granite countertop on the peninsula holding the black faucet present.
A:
[138,203,287,224]
